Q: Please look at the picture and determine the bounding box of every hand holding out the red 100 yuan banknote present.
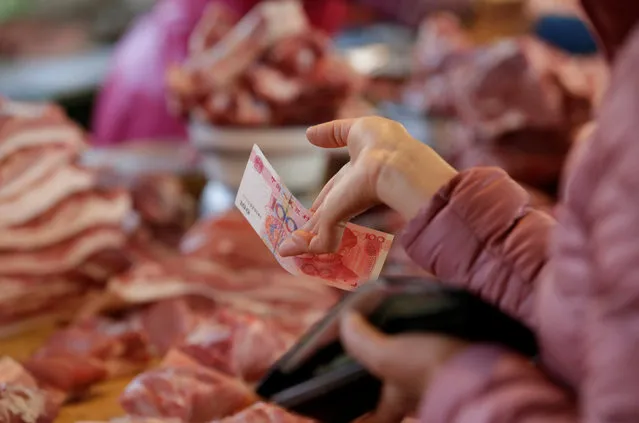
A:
[279,117,457,257]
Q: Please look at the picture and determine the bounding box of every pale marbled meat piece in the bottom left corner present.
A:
[0,357,59,423]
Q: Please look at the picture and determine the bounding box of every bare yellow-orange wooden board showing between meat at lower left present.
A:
[0,327,131,423]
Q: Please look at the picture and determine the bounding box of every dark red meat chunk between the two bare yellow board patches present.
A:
[25,318,150,393]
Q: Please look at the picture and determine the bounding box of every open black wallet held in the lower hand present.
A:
[257,278,537,423]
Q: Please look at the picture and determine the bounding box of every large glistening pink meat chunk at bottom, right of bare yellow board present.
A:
[120,351,256,423]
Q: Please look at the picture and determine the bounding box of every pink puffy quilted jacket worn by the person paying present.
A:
[403,0,639,423]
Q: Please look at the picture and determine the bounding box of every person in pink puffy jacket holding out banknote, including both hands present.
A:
[280,0,639,423]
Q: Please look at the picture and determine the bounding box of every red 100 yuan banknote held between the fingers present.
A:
[235,145,393,290]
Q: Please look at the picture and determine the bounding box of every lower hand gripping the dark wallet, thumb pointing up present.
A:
[340,313,468,423]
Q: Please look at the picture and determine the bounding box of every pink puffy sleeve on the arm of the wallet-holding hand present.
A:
[420,346,578,423]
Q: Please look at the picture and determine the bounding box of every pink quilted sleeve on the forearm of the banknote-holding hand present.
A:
[402,168,555,327]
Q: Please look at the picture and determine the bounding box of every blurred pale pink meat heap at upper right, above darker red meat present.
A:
[406,15,608,130]
